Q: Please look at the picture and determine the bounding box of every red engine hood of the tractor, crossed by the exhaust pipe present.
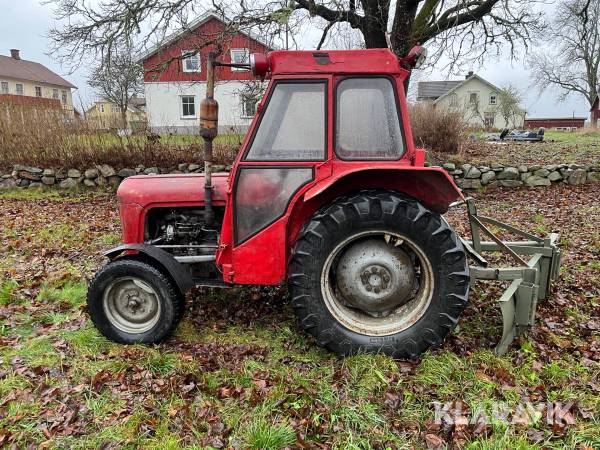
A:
[117,172,229,208]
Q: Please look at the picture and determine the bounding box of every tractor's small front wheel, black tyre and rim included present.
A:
[87,258,185,344]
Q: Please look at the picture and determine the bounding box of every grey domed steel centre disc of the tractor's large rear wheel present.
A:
[336,239,415,317]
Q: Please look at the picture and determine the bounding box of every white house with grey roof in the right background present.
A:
[417,72,525,129]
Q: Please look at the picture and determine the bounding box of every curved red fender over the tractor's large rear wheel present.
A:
[304,165,464,213]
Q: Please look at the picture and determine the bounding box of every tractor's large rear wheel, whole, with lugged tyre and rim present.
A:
[289,191,469,358]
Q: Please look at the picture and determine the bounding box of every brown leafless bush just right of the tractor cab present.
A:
[408,104,467,154]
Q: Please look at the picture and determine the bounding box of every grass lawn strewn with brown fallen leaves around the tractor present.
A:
[0,185,600,450]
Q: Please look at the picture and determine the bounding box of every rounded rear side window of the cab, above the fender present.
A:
[335,77,404,160]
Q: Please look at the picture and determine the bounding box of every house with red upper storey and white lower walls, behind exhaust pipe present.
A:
[141,12,270,134]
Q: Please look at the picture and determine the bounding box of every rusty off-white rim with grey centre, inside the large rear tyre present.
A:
[321,230,434,336]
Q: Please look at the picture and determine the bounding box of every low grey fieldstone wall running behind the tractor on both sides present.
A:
[0,163,600,189]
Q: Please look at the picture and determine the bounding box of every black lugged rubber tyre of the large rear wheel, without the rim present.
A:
[289,190,469,357]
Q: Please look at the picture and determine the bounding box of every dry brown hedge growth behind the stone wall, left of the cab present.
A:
[0,104,241,170]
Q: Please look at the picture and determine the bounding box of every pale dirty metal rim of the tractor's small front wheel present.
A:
[102,277,161,334]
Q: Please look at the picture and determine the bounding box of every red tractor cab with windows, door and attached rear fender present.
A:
[217,49,461,284]
